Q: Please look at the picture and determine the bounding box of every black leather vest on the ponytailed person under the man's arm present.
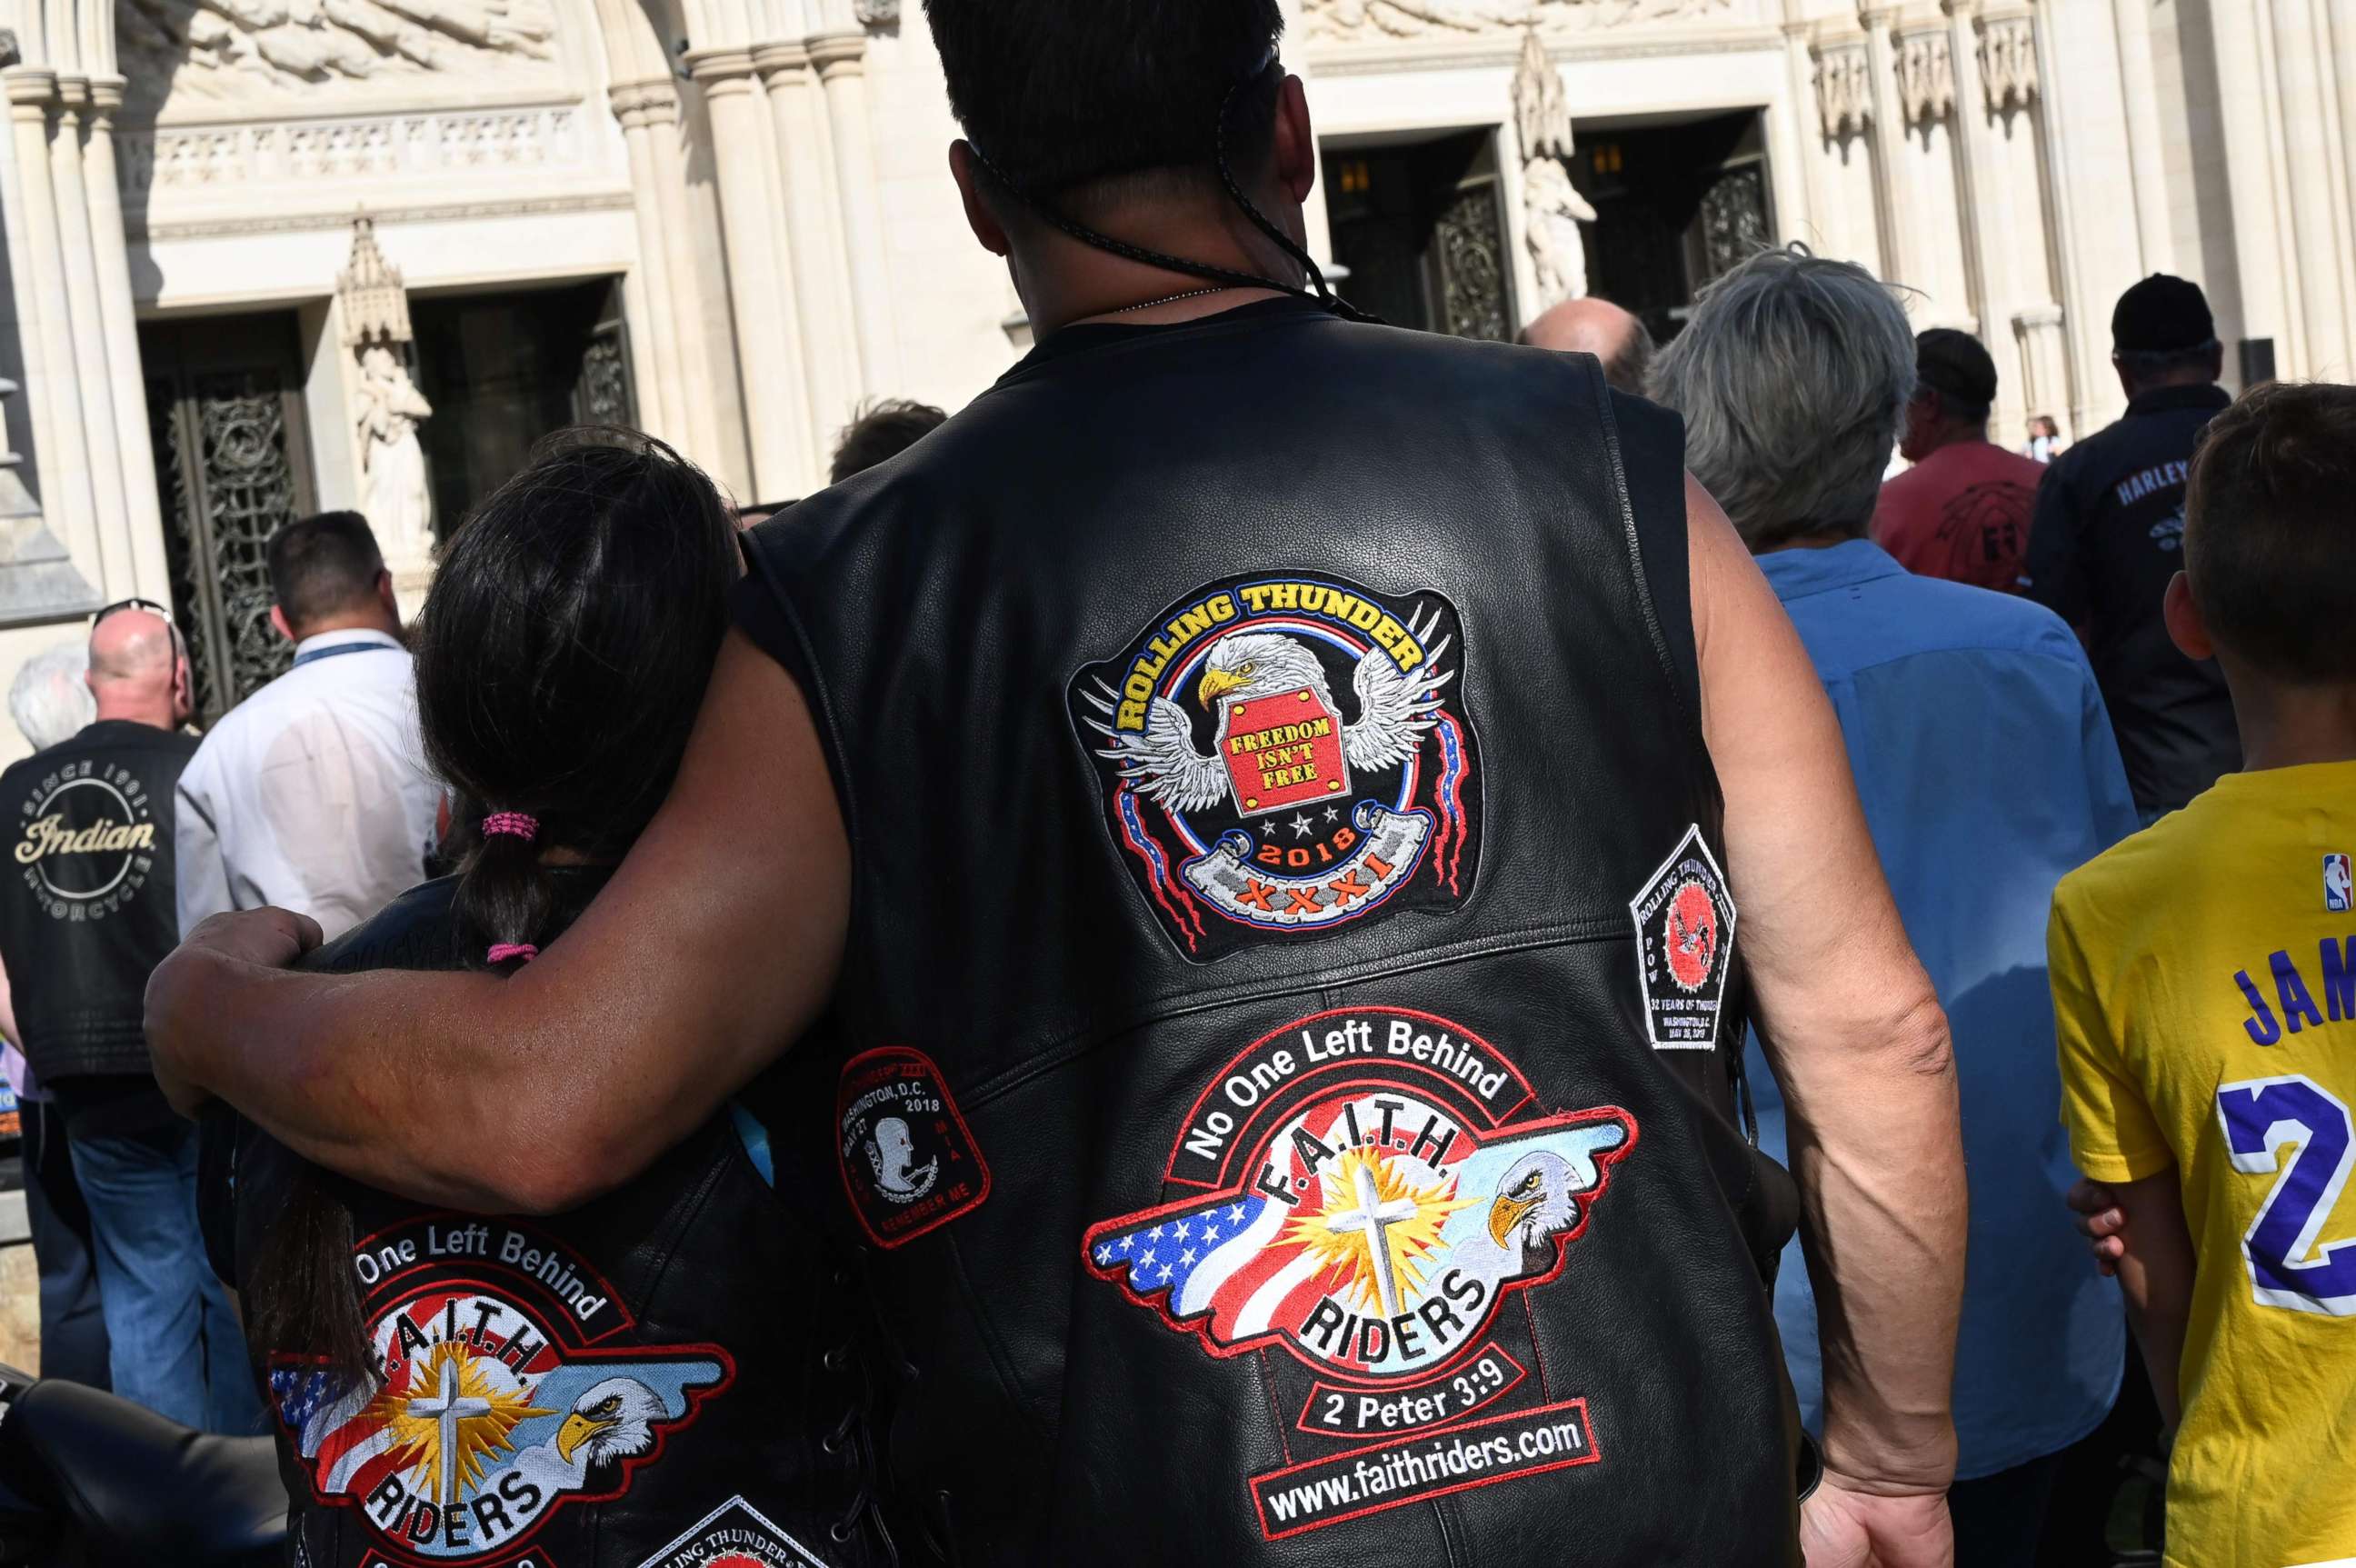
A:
[216,874,888,1568]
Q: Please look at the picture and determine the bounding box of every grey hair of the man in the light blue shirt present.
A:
[1652,245,1915,551]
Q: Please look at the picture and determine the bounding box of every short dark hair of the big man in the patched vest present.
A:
[923,0,1284,195]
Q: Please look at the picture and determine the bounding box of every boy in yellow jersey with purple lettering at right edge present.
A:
[2047,386,2356,1568]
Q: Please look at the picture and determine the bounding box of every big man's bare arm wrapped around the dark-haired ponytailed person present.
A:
[148,634,851,1213]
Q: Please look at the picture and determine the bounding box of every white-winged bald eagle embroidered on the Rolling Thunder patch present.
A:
[1083,610,1456,813]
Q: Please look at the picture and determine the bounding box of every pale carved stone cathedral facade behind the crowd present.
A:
[0,0,2356,751]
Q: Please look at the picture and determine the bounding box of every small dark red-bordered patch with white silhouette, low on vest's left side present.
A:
[834,1045,990,1248]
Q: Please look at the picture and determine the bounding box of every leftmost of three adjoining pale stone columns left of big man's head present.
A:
[690,49,811,499]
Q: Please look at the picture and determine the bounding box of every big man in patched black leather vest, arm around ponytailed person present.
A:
[151,0,1962,1568]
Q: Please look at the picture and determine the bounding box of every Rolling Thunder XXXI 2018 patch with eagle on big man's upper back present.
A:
[1072,574,1480,961]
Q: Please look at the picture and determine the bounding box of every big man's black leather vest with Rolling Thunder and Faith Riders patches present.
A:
[744,304,1798,1568]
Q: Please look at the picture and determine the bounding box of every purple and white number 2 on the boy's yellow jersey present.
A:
[2217,1074,2356,1318]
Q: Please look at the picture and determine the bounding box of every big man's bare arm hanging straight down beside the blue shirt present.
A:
[1687,483,1972,1493]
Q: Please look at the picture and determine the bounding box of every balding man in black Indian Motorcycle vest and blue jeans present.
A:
[0,598,262,1432]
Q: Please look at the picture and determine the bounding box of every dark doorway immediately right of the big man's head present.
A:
[1322,129,1515,342]
